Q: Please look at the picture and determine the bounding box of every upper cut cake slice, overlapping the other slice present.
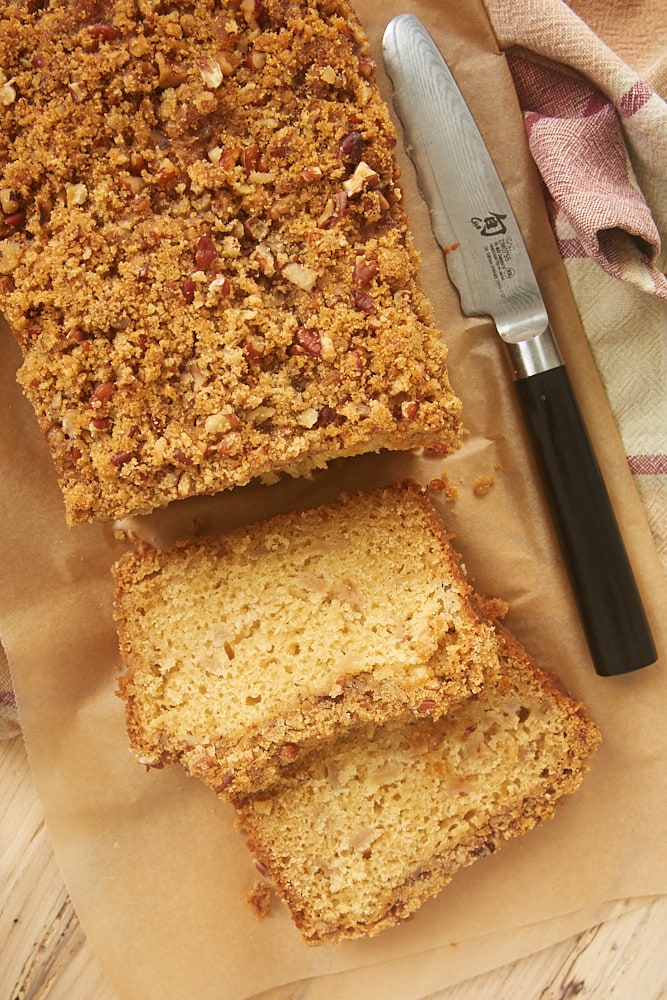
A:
[114,482,498,797]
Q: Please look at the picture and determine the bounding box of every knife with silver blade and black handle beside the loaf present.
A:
[383,14,657,677]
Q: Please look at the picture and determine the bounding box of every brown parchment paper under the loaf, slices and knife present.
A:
[0,0,667,1000]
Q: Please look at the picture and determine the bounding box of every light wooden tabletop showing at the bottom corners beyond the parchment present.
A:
[0,736,667,1000]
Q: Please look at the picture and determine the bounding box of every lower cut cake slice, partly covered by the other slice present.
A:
[236,626,600,944]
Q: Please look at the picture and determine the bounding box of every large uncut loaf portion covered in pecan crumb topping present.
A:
[0,0,460,523]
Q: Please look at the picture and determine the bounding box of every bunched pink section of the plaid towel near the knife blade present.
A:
[508,54,667,299]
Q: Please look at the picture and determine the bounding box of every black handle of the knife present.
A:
[515,365,657,677]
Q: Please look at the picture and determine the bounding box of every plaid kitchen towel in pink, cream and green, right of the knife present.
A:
[486,0,667,571]
